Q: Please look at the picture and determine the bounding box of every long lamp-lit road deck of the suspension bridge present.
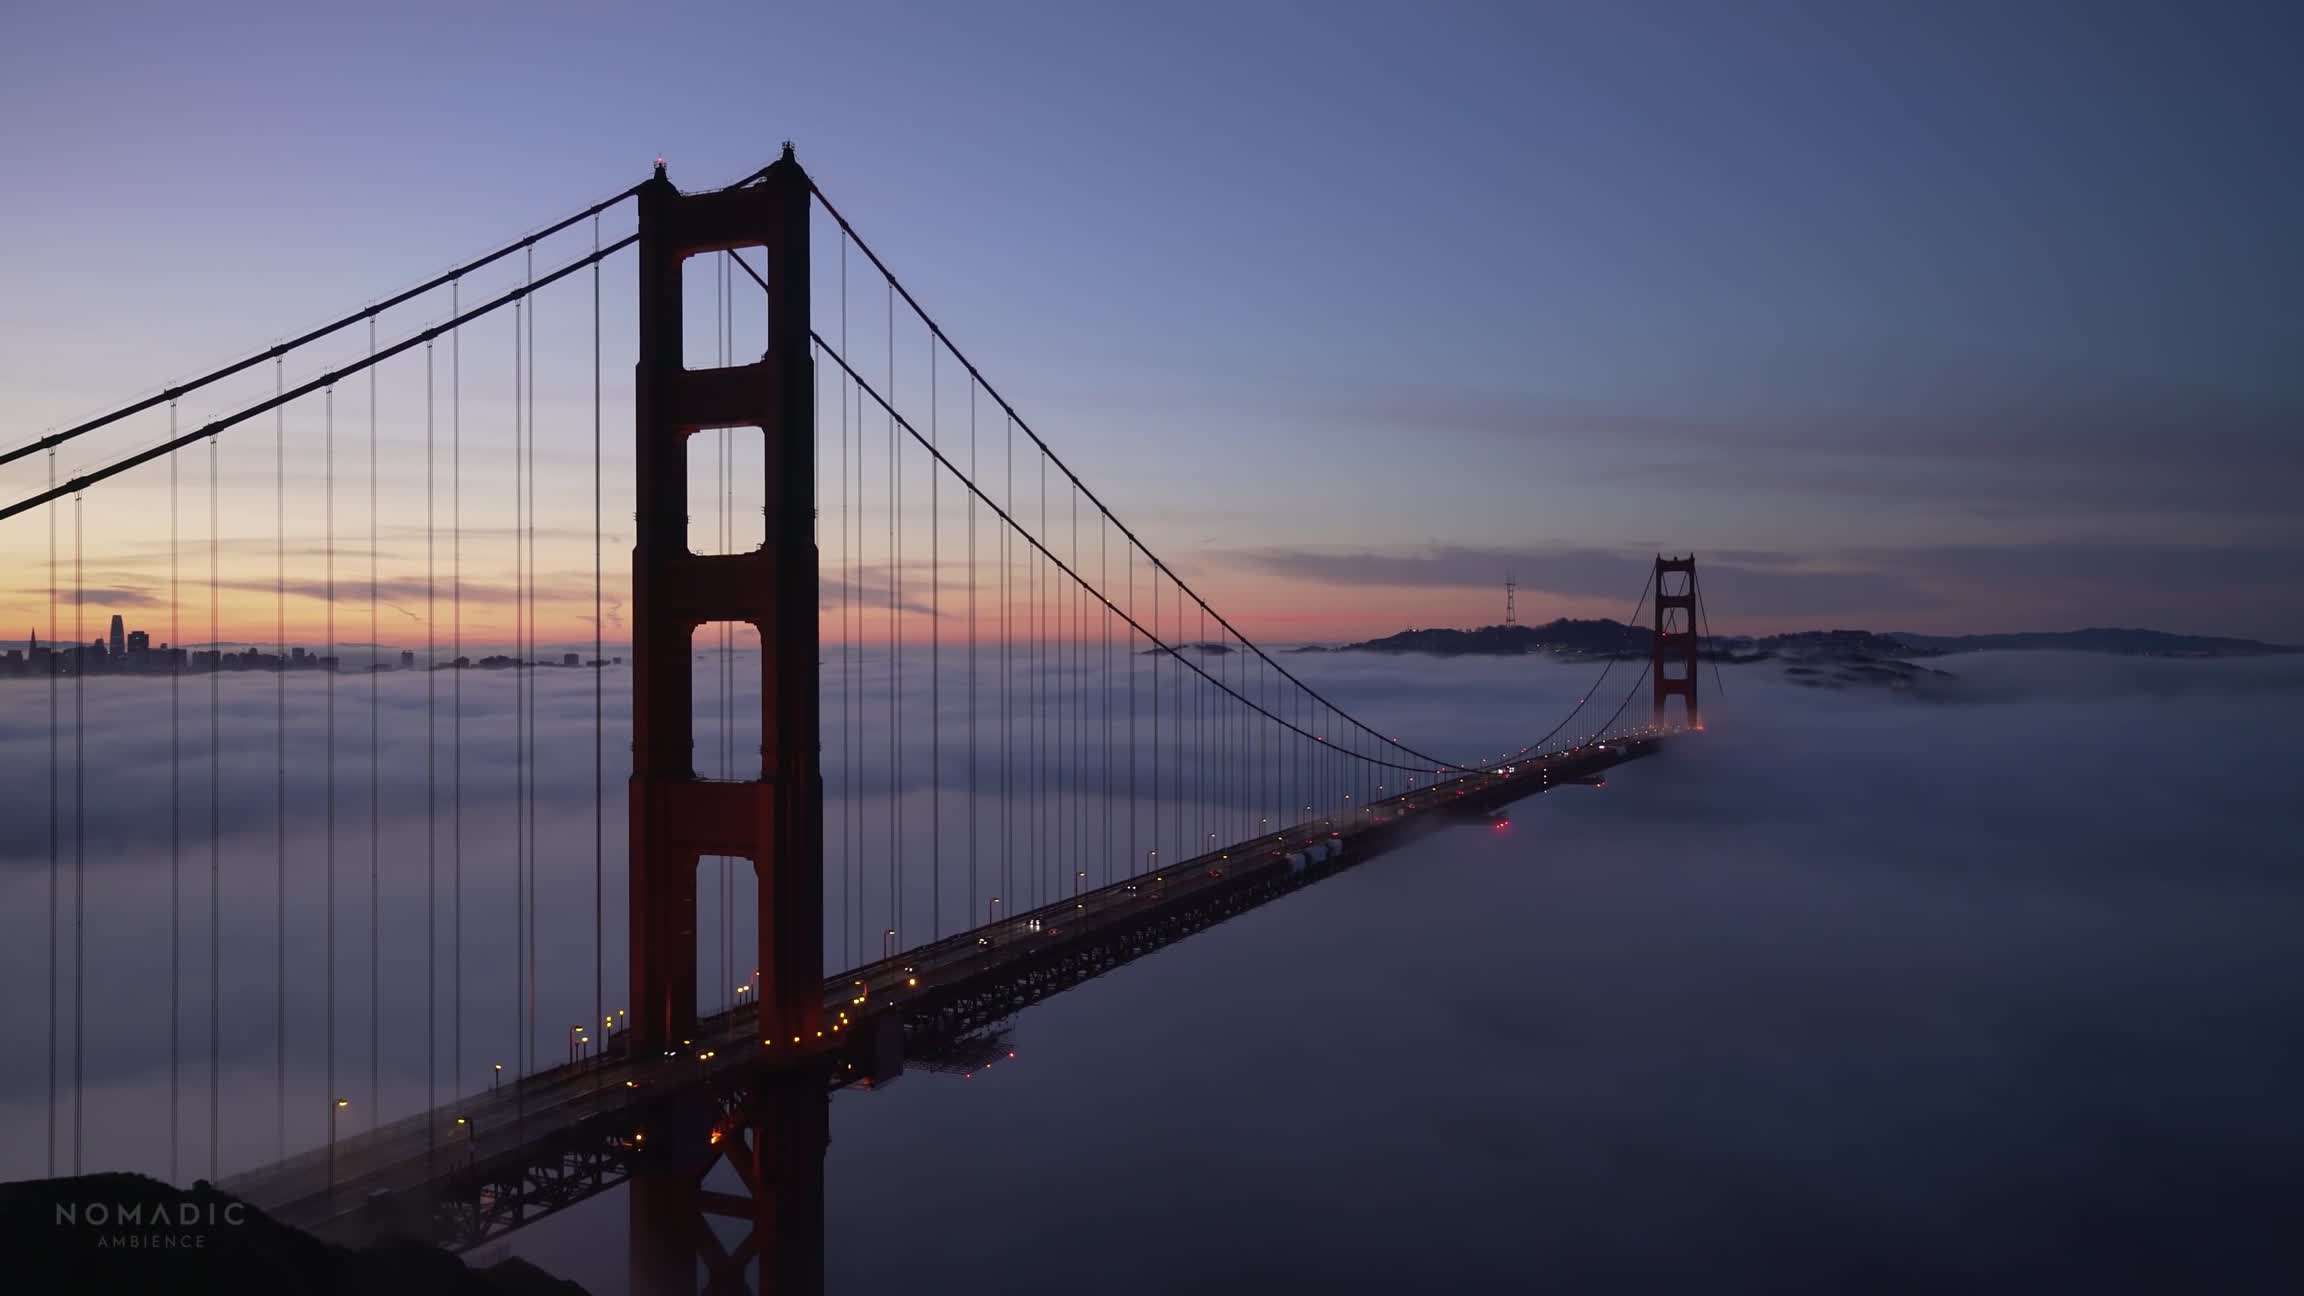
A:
[223,733,1663,1243]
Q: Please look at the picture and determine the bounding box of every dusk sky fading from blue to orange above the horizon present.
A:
[0,2,2304,646]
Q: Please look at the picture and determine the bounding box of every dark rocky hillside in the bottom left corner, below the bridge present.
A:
[0,1174,585,1296]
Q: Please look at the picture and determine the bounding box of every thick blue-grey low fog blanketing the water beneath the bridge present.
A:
[0,648,2304,1291]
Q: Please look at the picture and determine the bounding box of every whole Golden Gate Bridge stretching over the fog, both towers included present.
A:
[0,145,1705,1289]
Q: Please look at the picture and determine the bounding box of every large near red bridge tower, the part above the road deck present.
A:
[629,145,825,1047]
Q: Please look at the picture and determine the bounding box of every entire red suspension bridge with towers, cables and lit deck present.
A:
[0,145,1707,1291]
